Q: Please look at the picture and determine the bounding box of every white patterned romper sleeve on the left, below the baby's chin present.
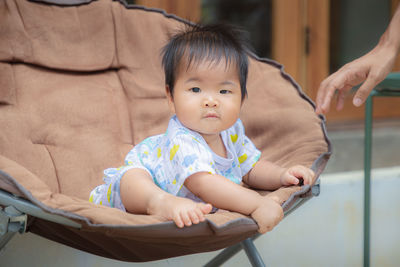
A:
[163,134,216,195]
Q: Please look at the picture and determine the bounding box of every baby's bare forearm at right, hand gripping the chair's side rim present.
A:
[243,159,315,190]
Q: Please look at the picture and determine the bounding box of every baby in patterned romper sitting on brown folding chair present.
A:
[90,25,314,233]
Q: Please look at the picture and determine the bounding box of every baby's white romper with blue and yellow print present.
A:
[89,116,261,211]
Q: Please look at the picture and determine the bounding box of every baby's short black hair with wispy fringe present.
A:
[162,24,252,101]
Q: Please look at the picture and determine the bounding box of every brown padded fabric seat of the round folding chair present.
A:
[0,0,329,261]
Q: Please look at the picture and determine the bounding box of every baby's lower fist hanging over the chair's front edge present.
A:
[251,196,283,234]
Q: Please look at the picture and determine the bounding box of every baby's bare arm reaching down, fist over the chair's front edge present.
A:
[185,172,283,233]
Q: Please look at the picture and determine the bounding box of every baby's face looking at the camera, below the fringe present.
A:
[168,60,242,139]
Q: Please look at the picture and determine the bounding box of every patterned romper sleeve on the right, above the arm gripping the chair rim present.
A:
[230,119,261,177]
